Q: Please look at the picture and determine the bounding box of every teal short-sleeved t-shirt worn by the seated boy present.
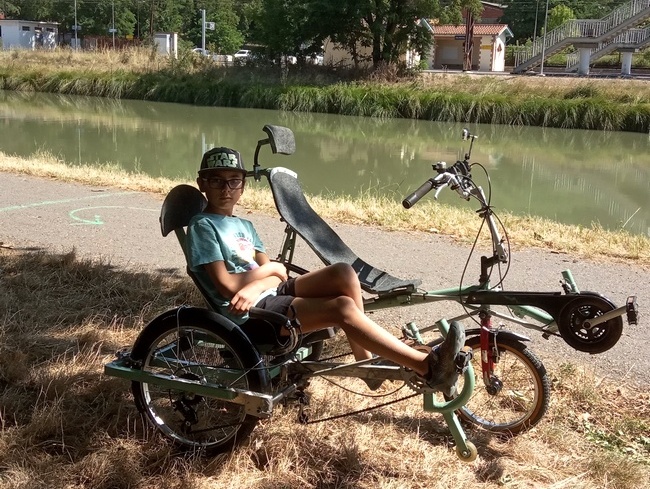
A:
[187,213,264,324]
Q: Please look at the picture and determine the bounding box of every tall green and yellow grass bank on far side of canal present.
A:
[0,47,650,133]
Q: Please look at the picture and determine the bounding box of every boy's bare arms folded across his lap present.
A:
[204,252,287,314]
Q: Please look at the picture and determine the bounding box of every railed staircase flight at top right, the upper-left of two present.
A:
[513,0,650,73]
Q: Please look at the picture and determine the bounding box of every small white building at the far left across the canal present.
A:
[0,19,59,49]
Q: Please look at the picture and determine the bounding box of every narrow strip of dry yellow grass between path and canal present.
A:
[0,152,650,265]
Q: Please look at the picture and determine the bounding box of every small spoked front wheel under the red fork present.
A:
[446,334,551,434]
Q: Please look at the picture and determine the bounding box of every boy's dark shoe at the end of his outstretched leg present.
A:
[425,321,472,397]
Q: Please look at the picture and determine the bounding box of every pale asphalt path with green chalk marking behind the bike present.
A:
[0,172,650,385]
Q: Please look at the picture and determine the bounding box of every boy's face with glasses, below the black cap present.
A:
[196,170,245,216]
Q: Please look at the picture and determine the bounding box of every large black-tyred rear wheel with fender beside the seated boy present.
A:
[131,312,264,453]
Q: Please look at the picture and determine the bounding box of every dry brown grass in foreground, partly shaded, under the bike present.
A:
[0,248,650,489]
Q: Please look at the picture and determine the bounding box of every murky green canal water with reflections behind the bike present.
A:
[0,91,650,238]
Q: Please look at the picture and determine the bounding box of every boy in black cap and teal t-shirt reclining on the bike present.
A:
[187,148,470,395]
